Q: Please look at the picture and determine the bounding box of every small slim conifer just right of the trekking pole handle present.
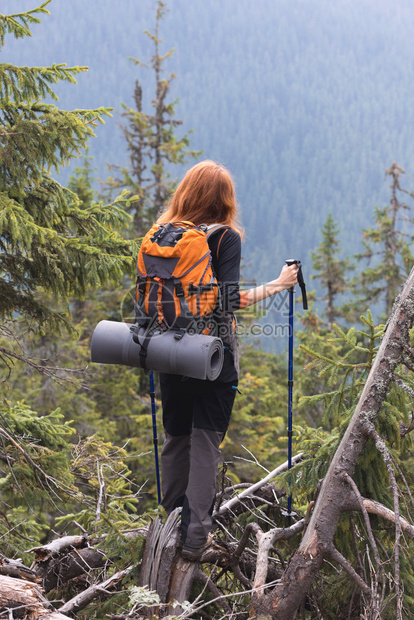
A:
[312,213,350,329]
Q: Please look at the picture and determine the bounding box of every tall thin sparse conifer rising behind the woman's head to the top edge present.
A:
[107,0,199,235]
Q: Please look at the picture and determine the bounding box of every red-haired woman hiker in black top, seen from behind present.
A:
[158,160,297,561]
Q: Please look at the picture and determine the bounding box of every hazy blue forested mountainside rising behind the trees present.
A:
[1,0,414,280]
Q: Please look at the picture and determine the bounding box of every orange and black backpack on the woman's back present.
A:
[135,221,228,338]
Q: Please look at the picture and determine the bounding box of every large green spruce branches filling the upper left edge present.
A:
[0,2,139,354]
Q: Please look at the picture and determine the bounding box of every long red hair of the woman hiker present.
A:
[158,159,243,235]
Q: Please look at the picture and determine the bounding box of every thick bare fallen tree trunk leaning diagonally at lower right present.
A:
[251,270,414,620]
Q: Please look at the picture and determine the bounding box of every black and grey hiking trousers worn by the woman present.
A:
[160,366,237,548]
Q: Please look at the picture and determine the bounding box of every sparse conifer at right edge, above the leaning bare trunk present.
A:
[347,162,414,319]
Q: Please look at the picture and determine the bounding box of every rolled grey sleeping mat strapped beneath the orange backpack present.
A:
[91,321,224,381]
